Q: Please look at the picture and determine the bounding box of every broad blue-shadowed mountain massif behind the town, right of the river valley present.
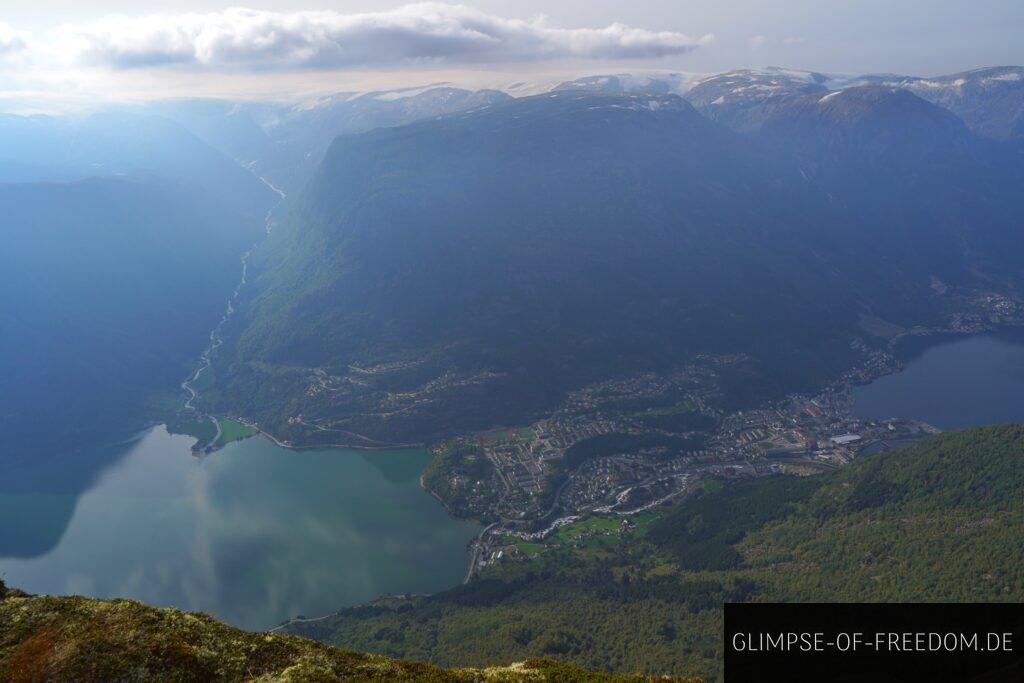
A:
[206,88,1021,444]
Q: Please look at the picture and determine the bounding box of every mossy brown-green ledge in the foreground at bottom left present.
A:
[0,583,692,682]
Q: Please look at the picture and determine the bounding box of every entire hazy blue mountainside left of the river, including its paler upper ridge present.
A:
[0,111,278,454]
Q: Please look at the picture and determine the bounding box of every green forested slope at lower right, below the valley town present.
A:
[289,425,1024,679]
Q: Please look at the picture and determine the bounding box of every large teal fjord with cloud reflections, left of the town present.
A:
[0,427,479,629]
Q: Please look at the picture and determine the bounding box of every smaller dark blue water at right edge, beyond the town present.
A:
[853,331,1024,429]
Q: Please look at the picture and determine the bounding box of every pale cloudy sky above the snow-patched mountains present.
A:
[0,0,1024,110]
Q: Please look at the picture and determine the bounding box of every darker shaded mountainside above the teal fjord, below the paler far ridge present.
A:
[0,177,262,454]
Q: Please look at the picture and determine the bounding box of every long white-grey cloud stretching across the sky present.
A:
[48,3,711,70]
